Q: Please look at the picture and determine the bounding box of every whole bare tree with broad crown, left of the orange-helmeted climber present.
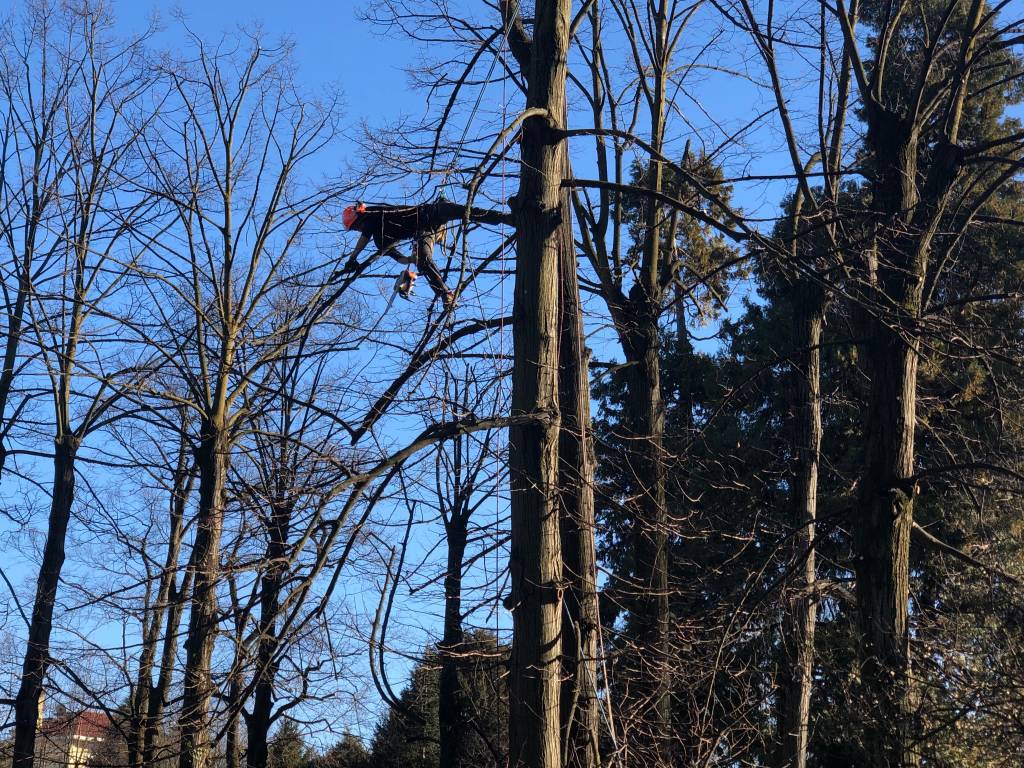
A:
[137,31,337,768]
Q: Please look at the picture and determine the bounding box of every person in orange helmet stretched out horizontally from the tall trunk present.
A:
[342,199,507,307]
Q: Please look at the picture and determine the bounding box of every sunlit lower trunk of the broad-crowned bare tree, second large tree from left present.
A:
[178,421,228,768]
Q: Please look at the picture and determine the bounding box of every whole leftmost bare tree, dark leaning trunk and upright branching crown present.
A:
[8,3,152,767]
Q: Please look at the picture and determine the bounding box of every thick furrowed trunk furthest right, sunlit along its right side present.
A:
[853,117,925,768]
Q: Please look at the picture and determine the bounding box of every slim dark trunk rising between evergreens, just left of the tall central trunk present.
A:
[437,528,467,768]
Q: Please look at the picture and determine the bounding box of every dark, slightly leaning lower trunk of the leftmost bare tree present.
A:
[11,434,80,768]
